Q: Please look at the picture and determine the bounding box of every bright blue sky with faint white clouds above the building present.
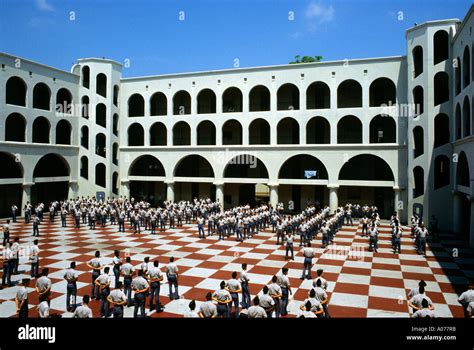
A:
[0,0,471,77]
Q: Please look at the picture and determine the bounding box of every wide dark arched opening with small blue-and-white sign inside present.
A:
[278,154,328,180]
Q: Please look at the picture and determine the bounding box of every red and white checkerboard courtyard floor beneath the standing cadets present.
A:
[0,219,474,317]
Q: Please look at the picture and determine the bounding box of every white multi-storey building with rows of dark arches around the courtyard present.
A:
[0,6,474,245]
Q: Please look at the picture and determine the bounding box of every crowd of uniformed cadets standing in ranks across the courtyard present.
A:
[2,198,474,318]
